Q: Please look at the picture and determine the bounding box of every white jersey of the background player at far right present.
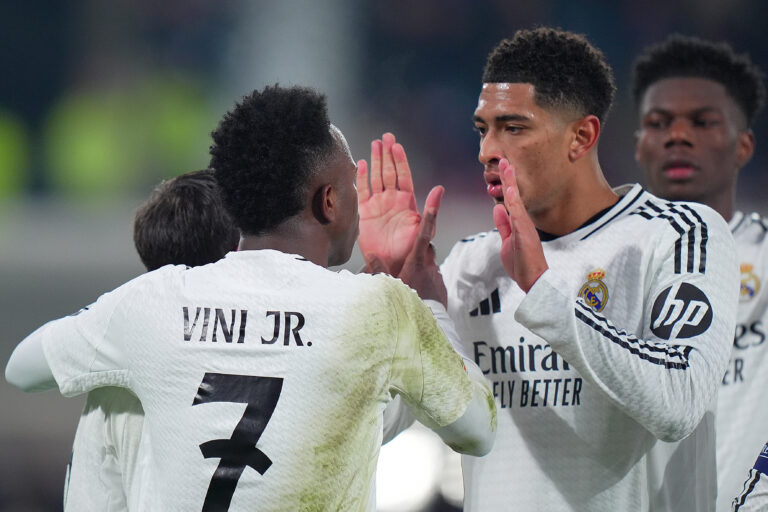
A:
[717,212,768,510]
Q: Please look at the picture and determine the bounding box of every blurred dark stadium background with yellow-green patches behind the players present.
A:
[0,0,768,512]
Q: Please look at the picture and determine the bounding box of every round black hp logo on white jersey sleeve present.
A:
[651,283,712,340]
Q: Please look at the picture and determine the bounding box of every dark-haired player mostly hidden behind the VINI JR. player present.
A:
[64,170,240,512]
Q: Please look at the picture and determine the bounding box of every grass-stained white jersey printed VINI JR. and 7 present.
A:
[39,250,495,511]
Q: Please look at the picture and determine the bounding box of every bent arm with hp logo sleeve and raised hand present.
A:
[494,161,739,441]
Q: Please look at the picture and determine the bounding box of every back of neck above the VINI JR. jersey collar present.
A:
[238,214,329,267]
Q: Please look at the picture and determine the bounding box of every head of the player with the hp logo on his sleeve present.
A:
[473,28,616,234]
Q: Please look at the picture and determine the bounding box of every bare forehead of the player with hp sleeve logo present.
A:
[475,83,545,123]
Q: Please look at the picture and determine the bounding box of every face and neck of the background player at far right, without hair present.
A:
[635,77,755,220]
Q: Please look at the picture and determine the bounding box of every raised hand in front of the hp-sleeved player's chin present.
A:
[493,158,549,293]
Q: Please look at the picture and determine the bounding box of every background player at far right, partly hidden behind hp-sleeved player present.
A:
[632,35,768,510]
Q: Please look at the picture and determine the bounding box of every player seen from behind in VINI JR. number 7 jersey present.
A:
[6,86,496,511]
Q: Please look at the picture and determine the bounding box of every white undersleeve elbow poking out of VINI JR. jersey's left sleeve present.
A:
[5,319,57,392]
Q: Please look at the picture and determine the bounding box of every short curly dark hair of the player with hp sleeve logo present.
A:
[483,27,616,123]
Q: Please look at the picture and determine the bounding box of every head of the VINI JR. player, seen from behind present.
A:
[210,85,358,266]
